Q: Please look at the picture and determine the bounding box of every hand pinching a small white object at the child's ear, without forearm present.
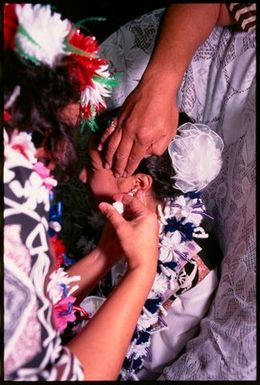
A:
[99,194,159,273]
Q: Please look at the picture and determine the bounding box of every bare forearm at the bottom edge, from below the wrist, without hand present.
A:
[68,271,155,380]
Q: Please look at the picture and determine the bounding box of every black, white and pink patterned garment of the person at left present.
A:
[4,128,84,382]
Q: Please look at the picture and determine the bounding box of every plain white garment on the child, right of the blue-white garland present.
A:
[137,269,218,380]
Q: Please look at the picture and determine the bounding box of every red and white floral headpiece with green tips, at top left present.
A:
[4,3,117,131]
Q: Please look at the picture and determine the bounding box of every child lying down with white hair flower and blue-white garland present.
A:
[78,109,223,380]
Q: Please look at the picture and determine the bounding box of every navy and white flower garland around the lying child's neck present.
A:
[120,192,211,380]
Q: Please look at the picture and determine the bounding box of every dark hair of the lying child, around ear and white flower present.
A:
[94,108,191,200]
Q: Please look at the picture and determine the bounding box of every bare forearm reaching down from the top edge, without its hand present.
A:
[142,3,231,92]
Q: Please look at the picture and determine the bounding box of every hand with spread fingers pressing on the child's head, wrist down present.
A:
[98,81,178,176]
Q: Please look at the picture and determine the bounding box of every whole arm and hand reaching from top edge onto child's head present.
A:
[98,4,233,176]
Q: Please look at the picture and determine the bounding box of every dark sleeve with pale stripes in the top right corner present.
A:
[226,3,256,32]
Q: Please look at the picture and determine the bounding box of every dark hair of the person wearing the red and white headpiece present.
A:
[3,50,83,177]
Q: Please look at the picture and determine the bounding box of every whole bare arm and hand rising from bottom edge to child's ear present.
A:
[67,196,158,380]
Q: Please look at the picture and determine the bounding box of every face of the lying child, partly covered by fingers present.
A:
[86,140,134,204]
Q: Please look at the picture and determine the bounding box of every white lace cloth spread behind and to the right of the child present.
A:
[101,10,256,380]
